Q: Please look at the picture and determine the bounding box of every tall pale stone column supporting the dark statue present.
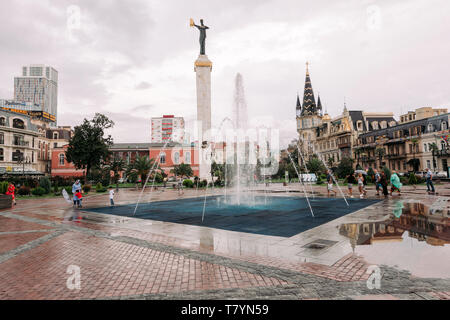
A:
[194,54,212,181]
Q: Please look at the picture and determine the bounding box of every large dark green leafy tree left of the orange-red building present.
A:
[66,113,114,175]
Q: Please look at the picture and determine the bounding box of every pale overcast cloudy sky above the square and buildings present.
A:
[0,0,450,144]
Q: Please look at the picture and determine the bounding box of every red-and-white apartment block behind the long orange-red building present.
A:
[151,115,184,143]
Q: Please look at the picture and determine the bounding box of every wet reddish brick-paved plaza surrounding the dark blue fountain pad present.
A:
[0,184,450,300]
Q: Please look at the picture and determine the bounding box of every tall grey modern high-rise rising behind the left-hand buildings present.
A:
[14,64,58,118]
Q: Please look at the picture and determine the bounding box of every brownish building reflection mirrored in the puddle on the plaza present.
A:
[339,201,450,251]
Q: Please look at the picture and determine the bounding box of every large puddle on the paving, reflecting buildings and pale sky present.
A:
[339,198,450,278]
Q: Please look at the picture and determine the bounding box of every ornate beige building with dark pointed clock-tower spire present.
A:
[296,65,396,166]
